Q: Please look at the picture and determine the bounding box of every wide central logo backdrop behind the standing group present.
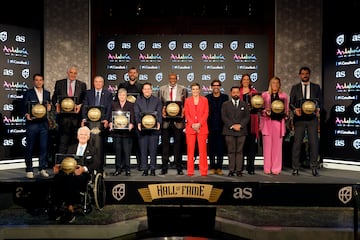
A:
[96,35,269,95]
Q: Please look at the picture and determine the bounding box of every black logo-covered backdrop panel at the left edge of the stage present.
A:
[0,25,42,161]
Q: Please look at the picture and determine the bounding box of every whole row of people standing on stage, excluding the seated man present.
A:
[23,66,322,181]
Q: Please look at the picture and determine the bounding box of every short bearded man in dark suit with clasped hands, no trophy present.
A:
[221,86,250,177]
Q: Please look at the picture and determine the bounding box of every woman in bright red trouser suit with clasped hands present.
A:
[184,83,209,176]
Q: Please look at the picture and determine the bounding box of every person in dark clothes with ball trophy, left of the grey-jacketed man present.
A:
[134,82,162,176]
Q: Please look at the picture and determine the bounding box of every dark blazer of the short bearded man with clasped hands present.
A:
[221,99,250,136]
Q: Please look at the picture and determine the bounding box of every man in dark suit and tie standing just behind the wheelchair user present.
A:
[81,76,112,172]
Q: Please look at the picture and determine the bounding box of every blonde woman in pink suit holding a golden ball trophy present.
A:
[260,77,289,175]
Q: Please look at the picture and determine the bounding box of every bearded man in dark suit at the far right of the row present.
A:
[290,67,323,176]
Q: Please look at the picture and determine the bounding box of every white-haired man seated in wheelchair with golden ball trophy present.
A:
[49,126,100,223]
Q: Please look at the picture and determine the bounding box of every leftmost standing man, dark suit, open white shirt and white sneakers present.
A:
[23,73,51,178]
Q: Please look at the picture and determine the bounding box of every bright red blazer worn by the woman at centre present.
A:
[184,96,209,137]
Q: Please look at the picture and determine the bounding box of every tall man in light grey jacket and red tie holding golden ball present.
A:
[158,73,188,175]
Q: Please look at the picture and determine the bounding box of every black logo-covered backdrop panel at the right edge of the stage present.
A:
[321,31,360,165]
